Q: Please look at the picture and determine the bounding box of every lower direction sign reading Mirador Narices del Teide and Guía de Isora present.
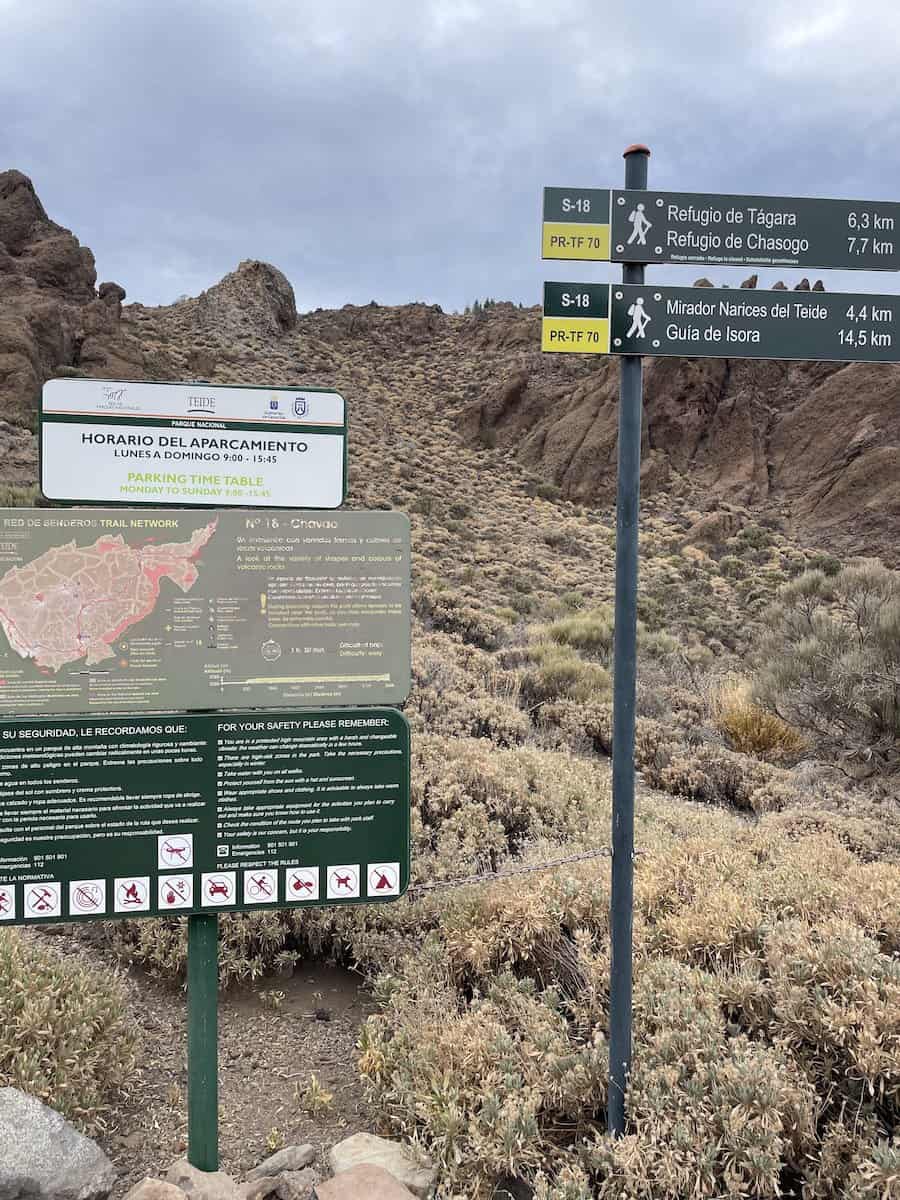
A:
[541,283,900,362]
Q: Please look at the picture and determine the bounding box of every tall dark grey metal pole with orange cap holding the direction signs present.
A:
[607,145,650,1136]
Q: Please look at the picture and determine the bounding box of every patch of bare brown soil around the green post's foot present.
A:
[38,931,377,1200]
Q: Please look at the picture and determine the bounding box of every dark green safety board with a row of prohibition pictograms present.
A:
[0,708,409,924]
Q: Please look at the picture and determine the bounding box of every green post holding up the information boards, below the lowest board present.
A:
[187,913,218,1171]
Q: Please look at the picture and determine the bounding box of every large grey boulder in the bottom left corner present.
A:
[0,1087,115,1200]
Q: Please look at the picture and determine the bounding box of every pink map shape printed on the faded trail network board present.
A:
[0,521,217,671]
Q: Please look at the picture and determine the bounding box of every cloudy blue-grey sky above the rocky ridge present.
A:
[0,0,900,310]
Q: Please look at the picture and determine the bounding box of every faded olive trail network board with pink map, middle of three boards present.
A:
[0,509,410,715]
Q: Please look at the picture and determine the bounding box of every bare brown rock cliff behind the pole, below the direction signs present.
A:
[466,297,900,562]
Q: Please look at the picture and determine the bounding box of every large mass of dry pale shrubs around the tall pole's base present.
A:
[360,825,900,1200]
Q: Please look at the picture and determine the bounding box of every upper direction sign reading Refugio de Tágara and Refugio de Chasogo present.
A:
[542,187,900,271]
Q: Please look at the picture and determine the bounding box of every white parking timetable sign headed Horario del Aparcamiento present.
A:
[41,379,347,509]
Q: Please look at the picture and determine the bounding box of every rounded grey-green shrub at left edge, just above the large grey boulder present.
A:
[0,930,138,1129]
